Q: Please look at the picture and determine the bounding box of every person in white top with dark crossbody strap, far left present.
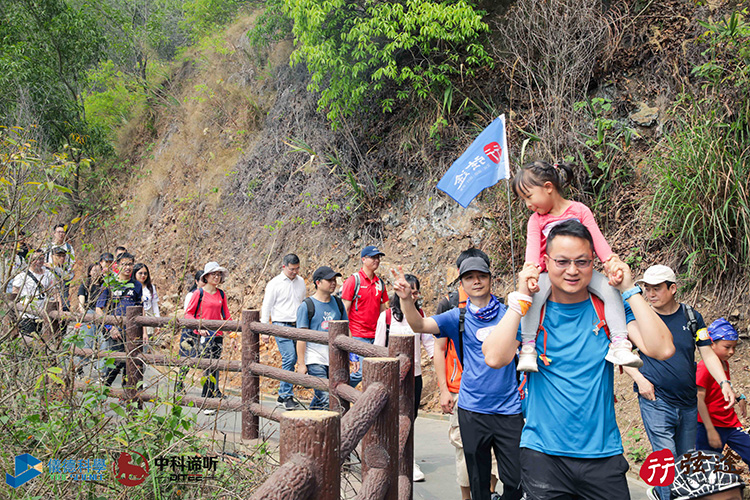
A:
[13,250,55,334]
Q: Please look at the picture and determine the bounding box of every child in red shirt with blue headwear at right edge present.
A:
[695,318,750,465]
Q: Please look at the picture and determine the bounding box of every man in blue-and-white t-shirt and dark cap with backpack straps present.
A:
[297,266,347,410]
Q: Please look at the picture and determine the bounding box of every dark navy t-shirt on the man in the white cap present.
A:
[625,303,711,408]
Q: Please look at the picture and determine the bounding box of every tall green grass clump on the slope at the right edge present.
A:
[652,12,750,284]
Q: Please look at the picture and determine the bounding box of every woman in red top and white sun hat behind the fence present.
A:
[185,262,232,402]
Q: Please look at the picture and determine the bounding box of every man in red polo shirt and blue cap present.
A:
[341,245,388,387]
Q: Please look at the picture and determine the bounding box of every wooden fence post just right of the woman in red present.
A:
[241,310,260,439]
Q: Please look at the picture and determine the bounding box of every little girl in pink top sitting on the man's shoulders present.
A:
[512,161,643,372]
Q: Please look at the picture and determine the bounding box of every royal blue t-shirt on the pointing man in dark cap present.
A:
[432,304,521,415]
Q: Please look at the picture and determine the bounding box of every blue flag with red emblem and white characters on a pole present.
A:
[437,115,510,208]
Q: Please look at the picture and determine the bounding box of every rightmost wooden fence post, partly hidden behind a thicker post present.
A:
[388,333,418,500]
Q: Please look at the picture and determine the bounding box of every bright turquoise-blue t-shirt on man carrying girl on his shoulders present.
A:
[518,299,622,458]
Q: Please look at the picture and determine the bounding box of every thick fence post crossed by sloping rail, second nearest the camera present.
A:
[361,358,399,500]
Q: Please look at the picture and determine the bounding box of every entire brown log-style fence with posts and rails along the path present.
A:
[45,306,414,500]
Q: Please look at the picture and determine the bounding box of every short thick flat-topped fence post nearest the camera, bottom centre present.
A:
[279,410,341,500]
